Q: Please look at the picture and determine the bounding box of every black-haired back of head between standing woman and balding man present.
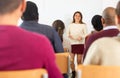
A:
[91,15,103,31]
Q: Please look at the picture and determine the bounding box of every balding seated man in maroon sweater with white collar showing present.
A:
[83,7,119,60]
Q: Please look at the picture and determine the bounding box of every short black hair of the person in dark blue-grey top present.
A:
[22,1,39,21]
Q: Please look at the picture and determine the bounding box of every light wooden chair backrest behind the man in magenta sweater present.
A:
[0,69,48,78]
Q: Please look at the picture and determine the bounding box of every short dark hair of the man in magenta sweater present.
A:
[0,0,22,15]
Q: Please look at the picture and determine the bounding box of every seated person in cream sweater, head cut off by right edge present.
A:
[83,1,120,66]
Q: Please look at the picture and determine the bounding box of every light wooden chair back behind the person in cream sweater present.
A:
[77,65,120,78]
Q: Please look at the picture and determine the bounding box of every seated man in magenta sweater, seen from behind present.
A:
[0,0,63,78]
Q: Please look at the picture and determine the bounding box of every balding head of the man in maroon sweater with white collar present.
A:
[102,7,116,25]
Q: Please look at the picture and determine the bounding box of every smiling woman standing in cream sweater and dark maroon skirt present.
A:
[67,11,87,78]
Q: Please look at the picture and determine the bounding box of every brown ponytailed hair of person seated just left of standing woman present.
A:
[52,20,65,41]
